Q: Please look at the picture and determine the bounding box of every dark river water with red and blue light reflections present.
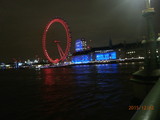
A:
[0,63,142,120]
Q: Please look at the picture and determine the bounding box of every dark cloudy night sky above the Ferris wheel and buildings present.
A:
[0,0,160,62]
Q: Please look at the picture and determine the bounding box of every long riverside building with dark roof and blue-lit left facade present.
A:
[72,39,160,64]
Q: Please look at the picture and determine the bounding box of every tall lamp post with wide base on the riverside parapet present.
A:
[131,0,160,83]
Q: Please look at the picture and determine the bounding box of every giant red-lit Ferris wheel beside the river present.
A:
[42,17,71,63]
